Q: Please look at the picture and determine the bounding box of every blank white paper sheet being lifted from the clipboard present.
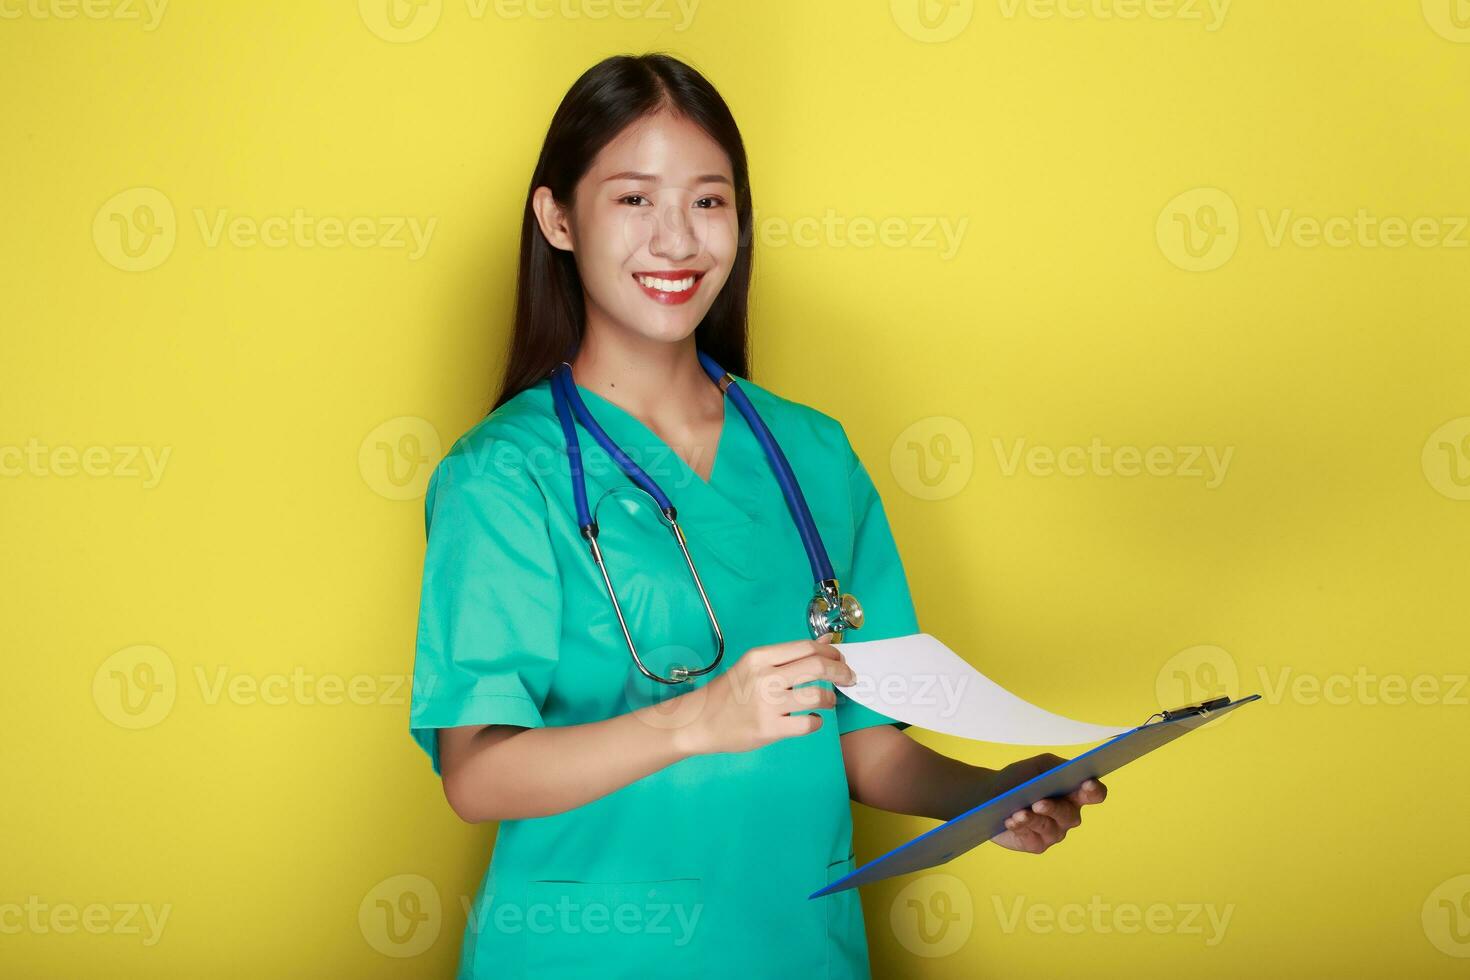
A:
[836,633,1138,745]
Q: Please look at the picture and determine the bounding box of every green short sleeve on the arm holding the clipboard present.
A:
[836,429,919,735]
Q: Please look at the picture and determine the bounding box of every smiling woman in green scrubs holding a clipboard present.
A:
[410,54,1105,977]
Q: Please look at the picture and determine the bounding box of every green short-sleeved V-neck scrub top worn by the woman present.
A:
[410,370,919,980]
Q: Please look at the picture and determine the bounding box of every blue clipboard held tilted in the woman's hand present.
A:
[807,693,1261,898]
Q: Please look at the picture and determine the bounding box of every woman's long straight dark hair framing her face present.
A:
[491,54,753,411]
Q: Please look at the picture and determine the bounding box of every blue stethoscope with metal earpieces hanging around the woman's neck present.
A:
[551,351,863,685]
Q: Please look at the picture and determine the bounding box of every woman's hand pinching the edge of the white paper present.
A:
[678,633,857,755]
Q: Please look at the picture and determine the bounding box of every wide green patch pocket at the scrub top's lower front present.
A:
[522,879,704,980]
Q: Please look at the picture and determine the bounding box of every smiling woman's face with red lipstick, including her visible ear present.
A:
[537,112,739,341]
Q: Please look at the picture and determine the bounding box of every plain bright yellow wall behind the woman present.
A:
[0,0,1470,977]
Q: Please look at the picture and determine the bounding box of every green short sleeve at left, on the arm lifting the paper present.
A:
[409,447,562,773]
